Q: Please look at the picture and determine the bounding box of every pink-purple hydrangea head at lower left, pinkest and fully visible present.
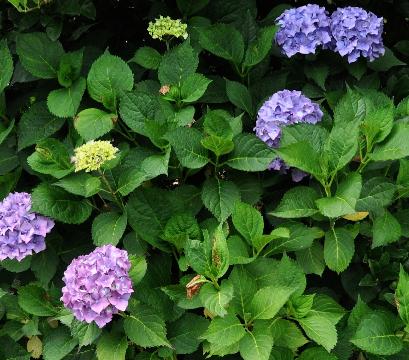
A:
[61,245,133,328]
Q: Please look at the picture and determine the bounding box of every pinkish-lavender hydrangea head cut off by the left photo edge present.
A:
[0,192,54,261]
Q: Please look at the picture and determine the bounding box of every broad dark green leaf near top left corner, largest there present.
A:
[16,32,64,79]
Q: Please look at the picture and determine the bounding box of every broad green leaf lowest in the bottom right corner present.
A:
[351,311,403,355]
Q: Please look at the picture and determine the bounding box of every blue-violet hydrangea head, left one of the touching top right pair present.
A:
[275,4,331,57]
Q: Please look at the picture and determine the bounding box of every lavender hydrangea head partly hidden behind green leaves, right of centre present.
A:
[254,90,323,181]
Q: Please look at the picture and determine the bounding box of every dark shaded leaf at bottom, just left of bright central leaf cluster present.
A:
[168,313,209,354]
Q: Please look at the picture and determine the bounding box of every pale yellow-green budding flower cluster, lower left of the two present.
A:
[71,140,118,172]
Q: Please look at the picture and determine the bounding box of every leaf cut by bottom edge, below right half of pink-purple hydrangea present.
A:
[96,332,128,360]
